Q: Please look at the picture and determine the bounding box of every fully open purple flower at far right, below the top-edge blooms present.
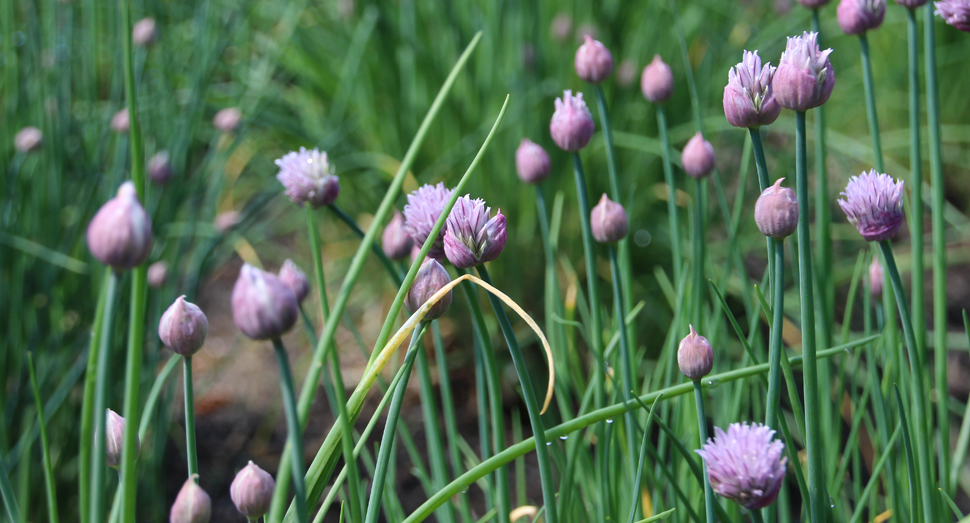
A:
[839,171,903,242]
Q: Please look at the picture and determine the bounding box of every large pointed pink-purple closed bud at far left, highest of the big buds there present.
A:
[87,182,152,270]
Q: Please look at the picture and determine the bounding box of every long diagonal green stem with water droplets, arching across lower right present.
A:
[403,336,879,523]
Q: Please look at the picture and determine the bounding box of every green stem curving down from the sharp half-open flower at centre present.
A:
[476,266,556,523]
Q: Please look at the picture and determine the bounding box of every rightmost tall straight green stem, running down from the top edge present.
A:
[923,7,944,495]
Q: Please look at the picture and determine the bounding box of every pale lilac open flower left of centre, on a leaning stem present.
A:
[276,147,340,209]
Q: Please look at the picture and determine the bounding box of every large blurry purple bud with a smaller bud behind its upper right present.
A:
[232,263,299,340]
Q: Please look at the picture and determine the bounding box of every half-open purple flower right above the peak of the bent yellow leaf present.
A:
[444,194,507,269]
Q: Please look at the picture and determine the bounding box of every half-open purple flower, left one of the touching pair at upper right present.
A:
[724,51,781,128]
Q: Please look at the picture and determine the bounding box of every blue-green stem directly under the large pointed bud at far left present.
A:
[88,271,120,521]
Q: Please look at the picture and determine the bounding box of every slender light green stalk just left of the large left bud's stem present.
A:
[80,268,112,523]
